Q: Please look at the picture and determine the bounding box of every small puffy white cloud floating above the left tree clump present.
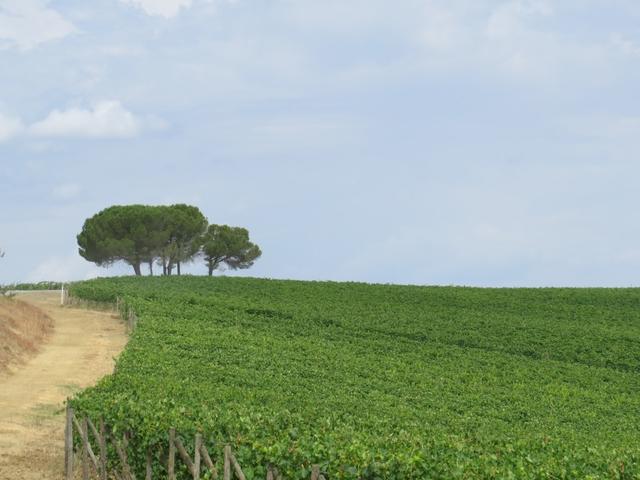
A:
[30,100,144,138]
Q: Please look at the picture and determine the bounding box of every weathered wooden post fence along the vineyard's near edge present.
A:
[65,405,326,480]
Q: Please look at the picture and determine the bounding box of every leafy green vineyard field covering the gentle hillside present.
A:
[72,277,640,479]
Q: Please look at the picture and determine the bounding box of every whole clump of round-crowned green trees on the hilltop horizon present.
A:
[77,204,262,275]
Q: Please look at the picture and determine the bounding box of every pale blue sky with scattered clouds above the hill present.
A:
[0,0,640,287]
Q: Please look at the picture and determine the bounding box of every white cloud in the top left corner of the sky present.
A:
[0,0,76,50]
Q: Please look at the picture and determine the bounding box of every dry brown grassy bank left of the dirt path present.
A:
[0,297,53,374]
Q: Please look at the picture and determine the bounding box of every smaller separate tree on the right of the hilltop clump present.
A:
[202,225,262,276]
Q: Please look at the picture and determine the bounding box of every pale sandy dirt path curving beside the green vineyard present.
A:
[0,292,126,480]
